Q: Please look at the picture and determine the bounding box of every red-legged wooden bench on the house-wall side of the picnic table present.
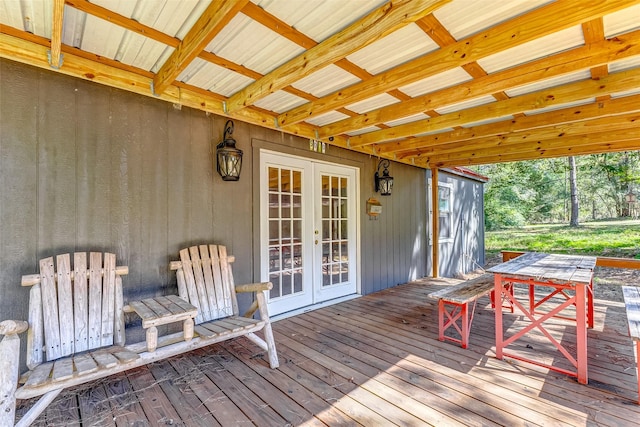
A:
[428,273,494,348]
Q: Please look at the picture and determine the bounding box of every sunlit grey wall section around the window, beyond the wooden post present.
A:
[427,170,485,277]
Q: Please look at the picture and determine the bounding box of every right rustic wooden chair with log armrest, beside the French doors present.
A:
[170,245,278,369]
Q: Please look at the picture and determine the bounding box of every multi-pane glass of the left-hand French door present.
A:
[269,167,303,300]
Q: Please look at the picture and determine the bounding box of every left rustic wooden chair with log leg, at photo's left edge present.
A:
[0,252,132,426]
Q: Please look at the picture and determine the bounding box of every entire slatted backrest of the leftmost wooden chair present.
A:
[23,252,128,369]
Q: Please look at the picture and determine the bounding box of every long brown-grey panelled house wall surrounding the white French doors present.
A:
[0,60,428,341]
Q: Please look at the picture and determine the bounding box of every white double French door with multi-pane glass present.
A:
[260,151,358,315]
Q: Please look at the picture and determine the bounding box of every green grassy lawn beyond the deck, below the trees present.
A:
[485,220,640,259]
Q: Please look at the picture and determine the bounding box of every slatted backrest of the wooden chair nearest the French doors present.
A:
[174,245,238,324]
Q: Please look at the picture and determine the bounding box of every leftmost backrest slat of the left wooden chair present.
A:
[40,257,62,360]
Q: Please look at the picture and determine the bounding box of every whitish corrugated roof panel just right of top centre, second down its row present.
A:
[347,24,438,74]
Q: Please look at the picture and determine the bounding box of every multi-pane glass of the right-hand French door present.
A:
[322,175,350,287]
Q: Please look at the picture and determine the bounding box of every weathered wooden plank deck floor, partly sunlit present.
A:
[18,280,640,427]
